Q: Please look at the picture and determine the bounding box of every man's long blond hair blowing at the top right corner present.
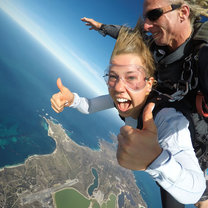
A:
[170,0,208,24]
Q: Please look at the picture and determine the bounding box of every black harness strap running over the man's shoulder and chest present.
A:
[164,21,208,100]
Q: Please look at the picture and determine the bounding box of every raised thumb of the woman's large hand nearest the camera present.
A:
[143,103,157,132]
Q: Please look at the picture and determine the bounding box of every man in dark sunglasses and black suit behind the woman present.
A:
[82,0,208,208]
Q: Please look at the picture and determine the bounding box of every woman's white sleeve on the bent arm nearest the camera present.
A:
[145,108,206,204]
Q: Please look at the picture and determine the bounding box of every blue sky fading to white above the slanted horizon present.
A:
[0,0,143,94]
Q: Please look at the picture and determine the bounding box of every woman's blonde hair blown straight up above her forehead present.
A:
[111,27,155,77]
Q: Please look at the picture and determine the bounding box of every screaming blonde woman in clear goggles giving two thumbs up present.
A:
[51,29,205,205]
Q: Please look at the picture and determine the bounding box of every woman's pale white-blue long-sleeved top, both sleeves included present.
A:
[70,93,206,208]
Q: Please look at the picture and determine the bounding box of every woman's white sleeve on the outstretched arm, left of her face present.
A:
[69,93,114,114]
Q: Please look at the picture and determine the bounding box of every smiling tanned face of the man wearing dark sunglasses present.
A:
[143,0,181,47]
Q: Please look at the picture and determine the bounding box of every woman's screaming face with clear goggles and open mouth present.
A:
[108,54,154,119]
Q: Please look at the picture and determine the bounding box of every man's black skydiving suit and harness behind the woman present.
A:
[99,22,208,208]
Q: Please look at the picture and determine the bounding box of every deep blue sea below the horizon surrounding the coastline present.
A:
[0,7,195,208]
